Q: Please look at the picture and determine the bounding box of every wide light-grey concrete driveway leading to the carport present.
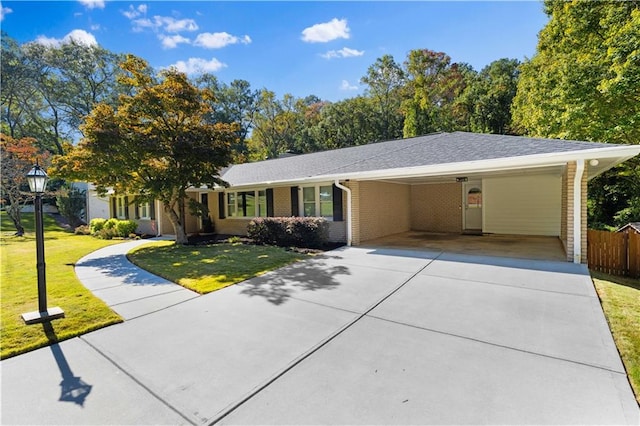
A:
[2,248,640,424]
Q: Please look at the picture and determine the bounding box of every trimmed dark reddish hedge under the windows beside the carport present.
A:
[247,217,329,248]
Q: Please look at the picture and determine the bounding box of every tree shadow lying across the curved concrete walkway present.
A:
[75,255,173,286]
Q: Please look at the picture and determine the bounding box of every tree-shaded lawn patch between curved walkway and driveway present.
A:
[127,241,308,294]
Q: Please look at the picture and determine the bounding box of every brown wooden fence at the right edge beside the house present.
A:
[587,229,640,278]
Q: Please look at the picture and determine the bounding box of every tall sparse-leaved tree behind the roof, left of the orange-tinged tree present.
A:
[360,55,405,140]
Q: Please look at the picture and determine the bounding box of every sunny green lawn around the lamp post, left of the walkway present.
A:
[0,212,122,359]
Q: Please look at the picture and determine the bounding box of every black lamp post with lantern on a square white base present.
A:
[22,162,64,325]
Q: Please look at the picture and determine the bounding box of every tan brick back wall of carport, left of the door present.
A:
[411,182,462,232]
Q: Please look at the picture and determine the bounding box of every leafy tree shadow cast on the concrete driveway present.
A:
[239,259,350,305]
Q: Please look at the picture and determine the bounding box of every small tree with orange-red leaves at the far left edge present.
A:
[0,133,48,236]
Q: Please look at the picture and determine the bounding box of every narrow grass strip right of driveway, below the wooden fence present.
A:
[591,271,640,403]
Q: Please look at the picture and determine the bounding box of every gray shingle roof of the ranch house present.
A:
[221,132,611,186]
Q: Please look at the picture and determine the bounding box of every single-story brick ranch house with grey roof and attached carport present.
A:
[102,132,640,263]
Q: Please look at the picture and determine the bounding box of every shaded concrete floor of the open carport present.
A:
[360,231,567,262]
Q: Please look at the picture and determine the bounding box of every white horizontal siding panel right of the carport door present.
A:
[482,175,562,236]
